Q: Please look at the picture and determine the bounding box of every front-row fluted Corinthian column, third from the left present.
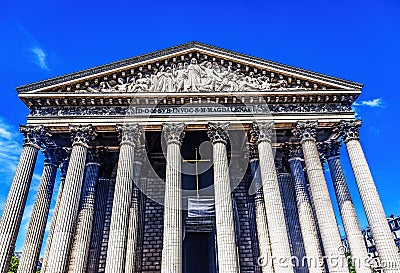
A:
[105,124,140,273]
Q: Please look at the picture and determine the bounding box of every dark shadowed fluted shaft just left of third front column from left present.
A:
[87,178,110,273]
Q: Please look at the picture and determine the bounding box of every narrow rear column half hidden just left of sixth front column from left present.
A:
[250,144,274,273]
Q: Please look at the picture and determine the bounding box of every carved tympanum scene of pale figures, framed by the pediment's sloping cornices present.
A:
[79,56,318,93]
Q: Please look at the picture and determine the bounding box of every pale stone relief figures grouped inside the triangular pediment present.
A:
[87,58,310,92]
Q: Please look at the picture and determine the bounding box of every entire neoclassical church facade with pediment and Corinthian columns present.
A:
[0,42,400,273]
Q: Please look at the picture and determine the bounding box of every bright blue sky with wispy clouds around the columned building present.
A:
[0,0,400,253]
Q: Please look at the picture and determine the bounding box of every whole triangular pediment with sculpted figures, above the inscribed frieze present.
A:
[17,42,362,94]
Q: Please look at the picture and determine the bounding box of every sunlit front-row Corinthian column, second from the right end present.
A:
[293,121,348,273]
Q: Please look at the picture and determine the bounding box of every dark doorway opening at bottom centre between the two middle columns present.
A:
[183,232,217,273]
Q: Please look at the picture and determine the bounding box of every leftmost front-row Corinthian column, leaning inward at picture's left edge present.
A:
[0,126,46,273]
